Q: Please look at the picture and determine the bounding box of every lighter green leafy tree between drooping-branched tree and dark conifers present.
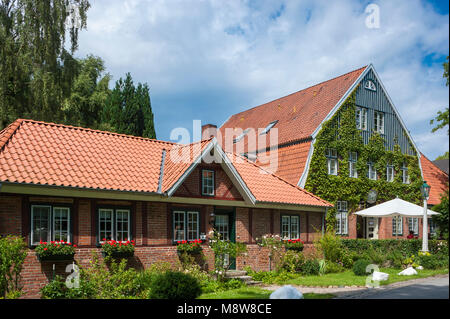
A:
[63,55,111,129]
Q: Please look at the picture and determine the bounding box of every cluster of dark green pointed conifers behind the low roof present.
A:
[102,73,156,138]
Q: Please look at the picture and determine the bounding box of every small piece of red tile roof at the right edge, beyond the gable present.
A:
[420,154,448,205]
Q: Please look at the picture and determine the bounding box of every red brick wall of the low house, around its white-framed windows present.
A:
[0,194,322,298]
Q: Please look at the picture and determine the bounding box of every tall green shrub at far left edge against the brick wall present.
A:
[0,236,27,297]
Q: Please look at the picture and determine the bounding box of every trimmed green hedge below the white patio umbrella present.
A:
[342,239,448,257]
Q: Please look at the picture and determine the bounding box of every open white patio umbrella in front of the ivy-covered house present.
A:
[355,197,439,218]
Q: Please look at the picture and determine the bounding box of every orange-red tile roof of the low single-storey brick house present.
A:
[0,120,330,207]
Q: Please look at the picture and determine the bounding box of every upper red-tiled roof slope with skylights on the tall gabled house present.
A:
[220,66,366,152]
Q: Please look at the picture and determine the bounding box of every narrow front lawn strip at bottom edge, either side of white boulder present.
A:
[198,287,334,299]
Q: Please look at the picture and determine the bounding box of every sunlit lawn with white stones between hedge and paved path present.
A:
[282,268,448,287]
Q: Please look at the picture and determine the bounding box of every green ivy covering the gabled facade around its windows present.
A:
[305,89,422,228]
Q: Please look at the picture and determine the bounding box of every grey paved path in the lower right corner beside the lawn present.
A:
[338,275,449,299]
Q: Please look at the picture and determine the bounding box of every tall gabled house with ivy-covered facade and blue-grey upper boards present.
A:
[219,65,448,239]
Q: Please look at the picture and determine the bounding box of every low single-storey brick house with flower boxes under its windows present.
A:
[0,120,331,297]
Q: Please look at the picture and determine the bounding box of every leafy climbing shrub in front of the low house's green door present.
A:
[209,230,247,280]
